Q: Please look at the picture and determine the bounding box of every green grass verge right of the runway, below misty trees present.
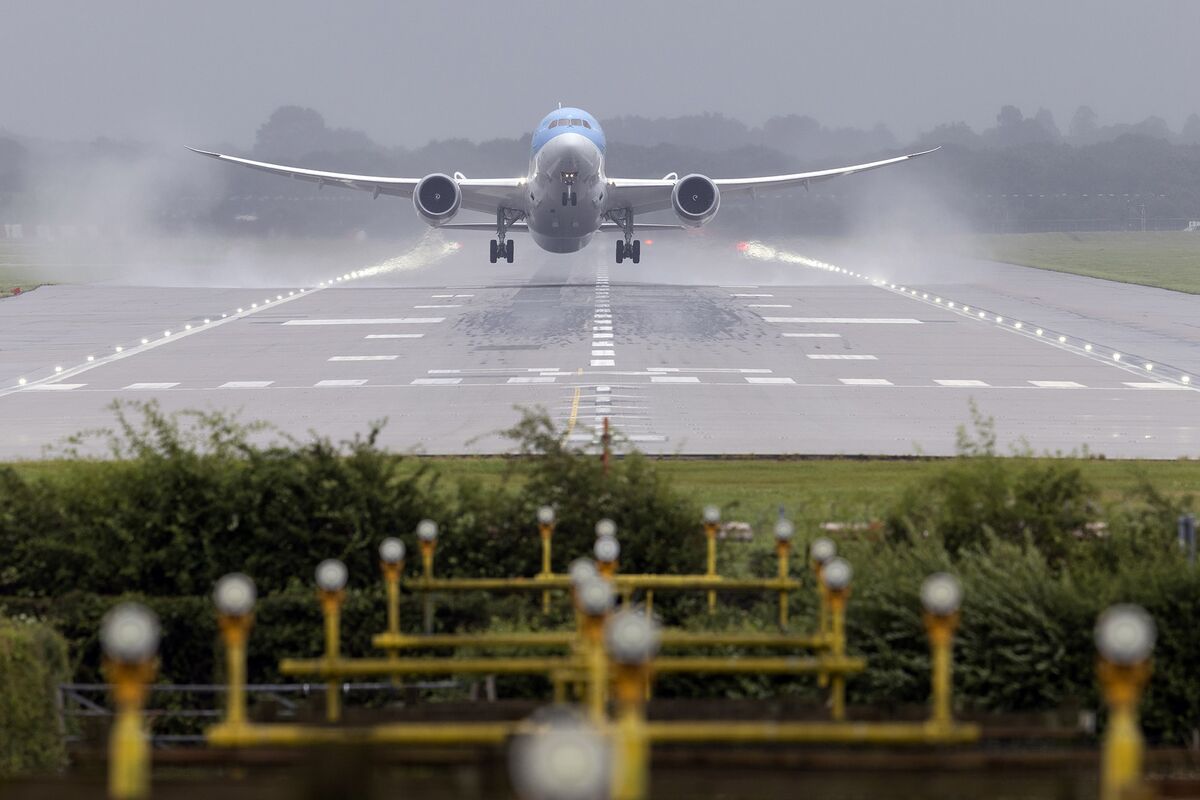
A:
[973,231,1200,294]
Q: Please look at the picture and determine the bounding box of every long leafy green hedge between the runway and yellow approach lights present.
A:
[0,405,1200,744]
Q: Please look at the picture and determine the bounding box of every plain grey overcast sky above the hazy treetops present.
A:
[0,0,1200,146]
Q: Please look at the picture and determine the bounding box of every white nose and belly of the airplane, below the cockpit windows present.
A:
[526,133,607,253]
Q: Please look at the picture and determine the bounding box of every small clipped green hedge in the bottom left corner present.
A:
[0,616,70,778]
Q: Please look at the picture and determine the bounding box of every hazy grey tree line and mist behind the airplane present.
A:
[0,106,1200,236]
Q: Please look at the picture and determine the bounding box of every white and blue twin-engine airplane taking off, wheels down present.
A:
[188,107,940,264]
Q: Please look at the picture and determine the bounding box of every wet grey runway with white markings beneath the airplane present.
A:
[0,234,1200,459]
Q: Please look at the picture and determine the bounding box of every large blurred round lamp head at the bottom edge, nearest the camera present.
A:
[509,718,612,800]
